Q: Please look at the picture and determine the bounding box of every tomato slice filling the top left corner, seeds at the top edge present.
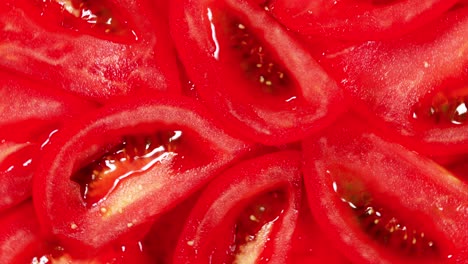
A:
[0,0,180,101]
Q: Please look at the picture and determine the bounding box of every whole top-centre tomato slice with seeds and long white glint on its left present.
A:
[170,0,346,145]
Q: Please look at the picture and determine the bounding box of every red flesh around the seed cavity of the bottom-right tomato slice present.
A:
[303,116,468,263]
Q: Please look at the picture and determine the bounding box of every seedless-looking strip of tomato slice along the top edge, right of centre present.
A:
[266,0,458,40]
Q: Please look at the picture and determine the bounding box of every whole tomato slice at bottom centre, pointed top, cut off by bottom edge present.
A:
[174,151,302,263]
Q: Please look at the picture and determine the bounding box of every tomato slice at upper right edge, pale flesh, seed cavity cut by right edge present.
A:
[314,8,468,156]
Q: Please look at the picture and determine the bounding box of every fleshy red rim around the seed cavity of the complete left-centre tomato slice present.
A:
[33,98,253,252]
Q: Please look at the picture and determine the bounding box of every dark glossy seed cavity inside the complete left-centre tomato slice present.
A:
[71,130,182,207]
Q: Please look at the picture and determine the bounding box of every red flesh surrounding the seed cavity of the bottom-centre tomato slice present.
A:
[173,151,301,263]
